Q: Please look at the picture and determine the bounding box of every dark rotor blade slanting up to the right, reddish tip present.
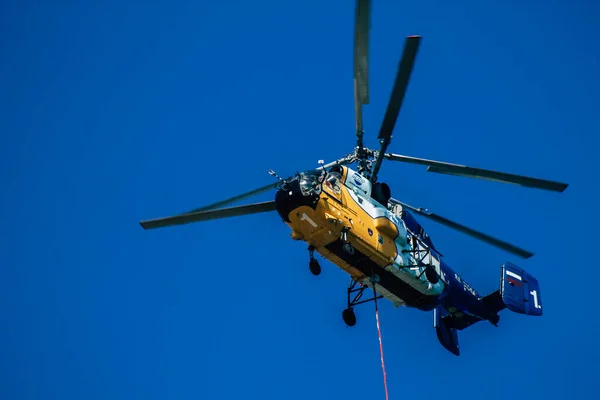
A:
[371,36,421,182]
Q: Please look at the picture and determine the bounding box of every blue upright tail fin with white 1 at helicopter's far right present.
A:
[482,262,542,316]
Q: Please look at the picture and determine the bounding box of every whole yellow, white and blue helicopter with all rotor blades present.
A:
[140,0,568,356]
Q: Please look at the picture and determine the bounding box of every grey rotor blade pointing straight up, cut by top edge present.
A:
[354,0,371,148]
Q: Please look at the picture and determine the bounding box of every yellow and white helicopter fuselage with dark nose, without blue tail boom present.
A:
[276,166,444,309]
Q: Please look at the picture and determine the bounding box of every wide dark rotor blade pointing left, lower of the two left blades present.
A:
[140,200,275,229]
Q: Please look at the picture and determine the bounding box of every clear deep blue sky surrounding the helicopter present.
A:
[0,0,600,400]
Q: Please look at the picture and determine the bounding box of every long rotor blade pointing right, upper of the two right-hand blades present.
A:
[385,153,569,192]
